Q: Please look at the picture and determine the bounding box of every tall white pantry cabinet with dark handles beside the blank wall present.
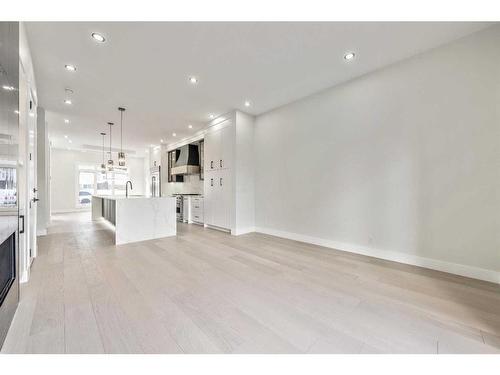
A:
[204,118,234,230]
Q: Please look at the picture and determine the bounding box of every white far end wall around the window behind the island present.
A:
[50,148,145,213]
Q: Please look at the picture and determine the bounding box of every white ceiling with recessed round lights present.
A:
[26,22,489,154]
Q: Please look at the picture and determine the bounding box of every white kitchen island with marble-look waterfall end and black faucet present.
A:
[92,195,177,245]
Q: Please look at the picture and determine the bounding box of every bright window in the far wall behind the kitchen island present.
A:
[76,164,129,208]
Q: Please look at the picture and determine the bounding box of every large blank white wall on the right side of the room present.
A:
[255,26,500,282]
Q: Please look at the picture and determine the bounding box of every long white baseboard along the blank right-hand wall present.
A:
[255,227,500,284]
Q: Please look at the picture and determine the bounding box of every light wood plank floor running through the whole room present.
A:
[2,213,500,353]
